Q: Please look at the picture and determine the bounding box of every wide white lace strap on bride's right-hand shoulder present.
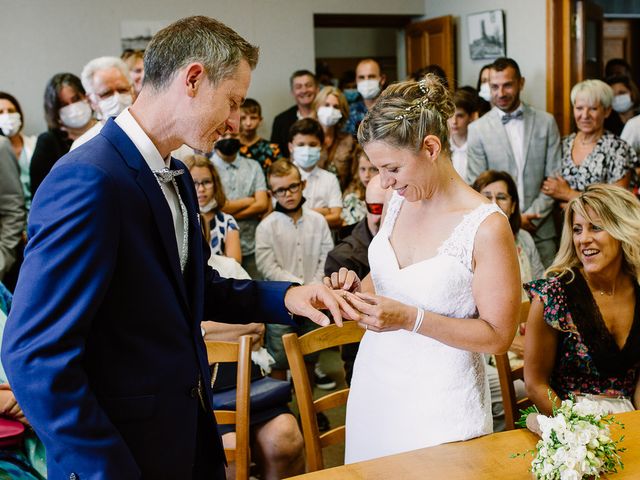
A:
[438,203,506,271]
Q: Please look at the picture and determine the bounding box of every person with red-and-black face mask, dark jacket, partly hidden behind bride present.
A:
[324,175,387,384]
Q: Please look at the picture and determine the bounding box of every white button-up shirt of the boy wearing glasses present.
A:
[256,210,333,284]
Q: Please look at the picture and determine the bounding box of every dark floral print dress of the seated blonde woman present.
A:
[524,269,640,400]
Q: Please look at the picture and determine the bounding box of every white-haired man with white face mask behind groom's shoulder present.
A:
[71,57,133,150]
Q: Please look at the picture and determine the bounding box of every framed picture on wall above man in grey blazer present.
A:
[467,10,507,60]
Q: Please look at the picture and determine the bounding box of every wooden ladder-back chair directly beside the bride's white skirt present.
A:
[282,321,364,472]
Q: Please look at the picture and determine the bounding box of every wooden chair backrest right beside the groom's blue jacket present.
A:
[205,335,251,480]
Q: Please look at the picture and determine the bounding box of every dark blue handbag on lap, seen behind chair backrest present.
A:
[213,377,291,411]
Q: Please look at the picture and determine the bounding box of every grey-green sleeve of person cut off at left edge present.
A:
[0,136,26,280]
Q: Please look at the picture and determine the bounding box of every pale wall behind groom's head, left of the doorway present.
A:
[0,0,425,135]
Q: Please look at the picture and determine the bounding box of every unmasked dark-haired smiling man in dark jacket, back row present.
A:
[271,70,319,157]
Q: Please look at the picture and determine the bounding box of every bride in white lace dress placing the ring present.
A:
[325,76,520,463]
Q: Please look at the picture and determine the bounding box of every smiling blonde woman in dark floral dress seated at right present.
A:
[524,185,640,415]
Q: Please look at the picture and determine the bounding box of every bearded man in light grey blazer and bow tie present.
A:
[467,58,560,266]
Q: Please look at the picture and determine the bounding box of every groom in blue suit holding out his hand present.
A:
[2,17,350,480]
